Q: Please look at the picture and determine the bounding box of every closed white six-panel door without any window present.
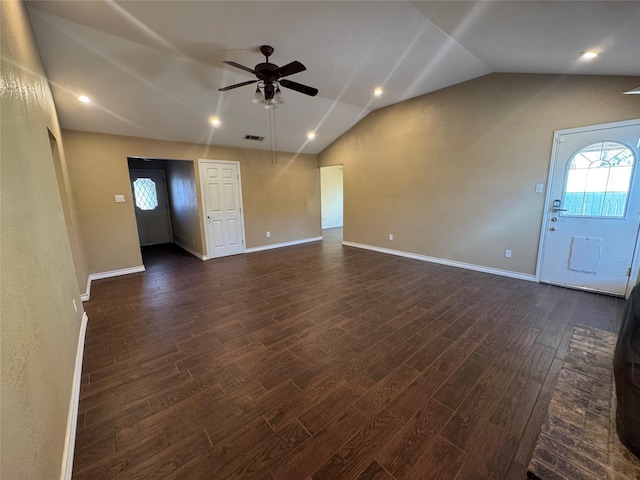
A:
[200,160,244,258]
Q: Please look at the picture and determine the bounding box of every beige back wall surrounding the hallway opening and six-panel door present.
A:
[64,130,321,273]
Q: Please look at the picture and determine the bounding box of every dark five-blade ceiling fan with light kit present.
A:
[218,45,318,105]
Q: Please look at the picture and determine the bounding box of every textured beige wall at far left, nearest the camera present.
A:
[0,1,84,480]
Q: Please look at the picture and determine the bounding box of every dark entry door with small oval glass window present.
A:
[129,170,171,245]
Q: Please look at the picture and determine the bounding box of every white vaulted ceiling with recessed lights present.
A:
[27,0,640,153]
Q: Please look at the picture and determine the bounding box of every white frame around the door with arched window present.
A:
[536,119,640,298]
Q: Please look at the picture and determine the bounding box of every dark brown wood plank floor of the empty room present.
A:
[73,230,624,480]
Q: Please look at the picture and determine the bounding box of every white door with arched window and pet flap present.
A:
[540,120,640,296]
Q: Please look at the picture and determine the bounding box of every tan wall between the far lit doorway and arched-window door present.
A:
[319,74,640,274]
